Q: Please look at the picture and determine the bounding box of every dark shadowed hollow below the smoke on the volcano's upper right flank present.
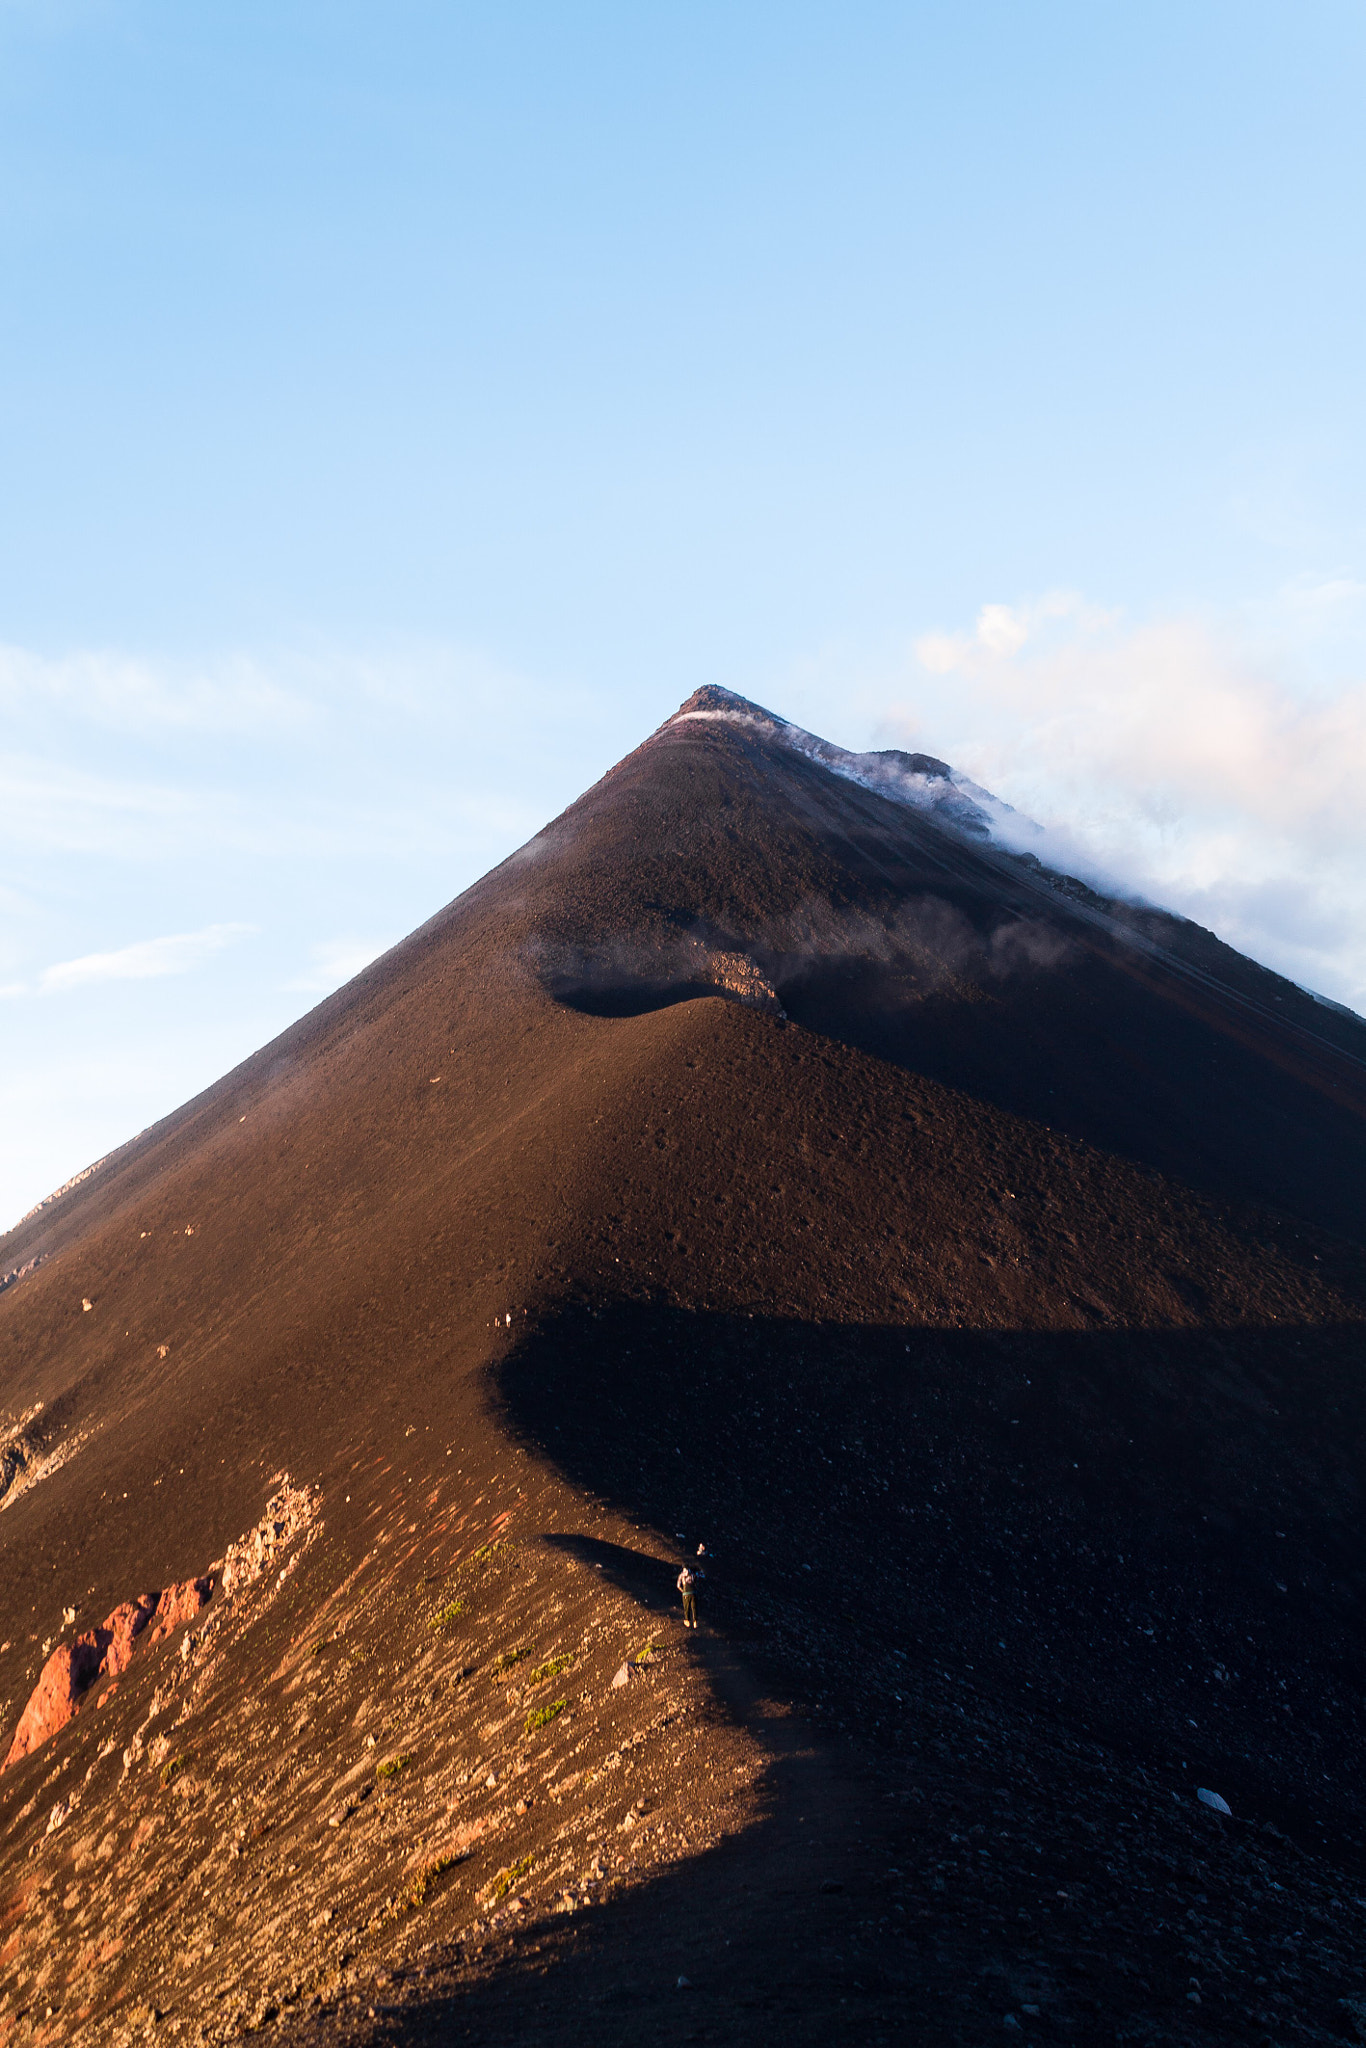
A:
[774,942,1366,1239]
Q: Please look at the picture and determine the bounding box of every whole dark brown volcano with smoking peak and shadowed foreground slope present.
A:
[0,688,1366,2044]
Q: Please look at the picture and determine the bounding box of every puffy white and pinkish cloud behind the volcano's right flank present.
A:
[883,578,1366,1008]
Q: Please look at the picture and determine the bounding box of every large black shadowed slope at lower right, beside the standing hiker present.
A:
[328,1303,1366,2048]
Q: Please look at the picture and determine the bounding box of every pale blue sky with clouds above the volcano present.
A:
[0,0,1366,1217]
